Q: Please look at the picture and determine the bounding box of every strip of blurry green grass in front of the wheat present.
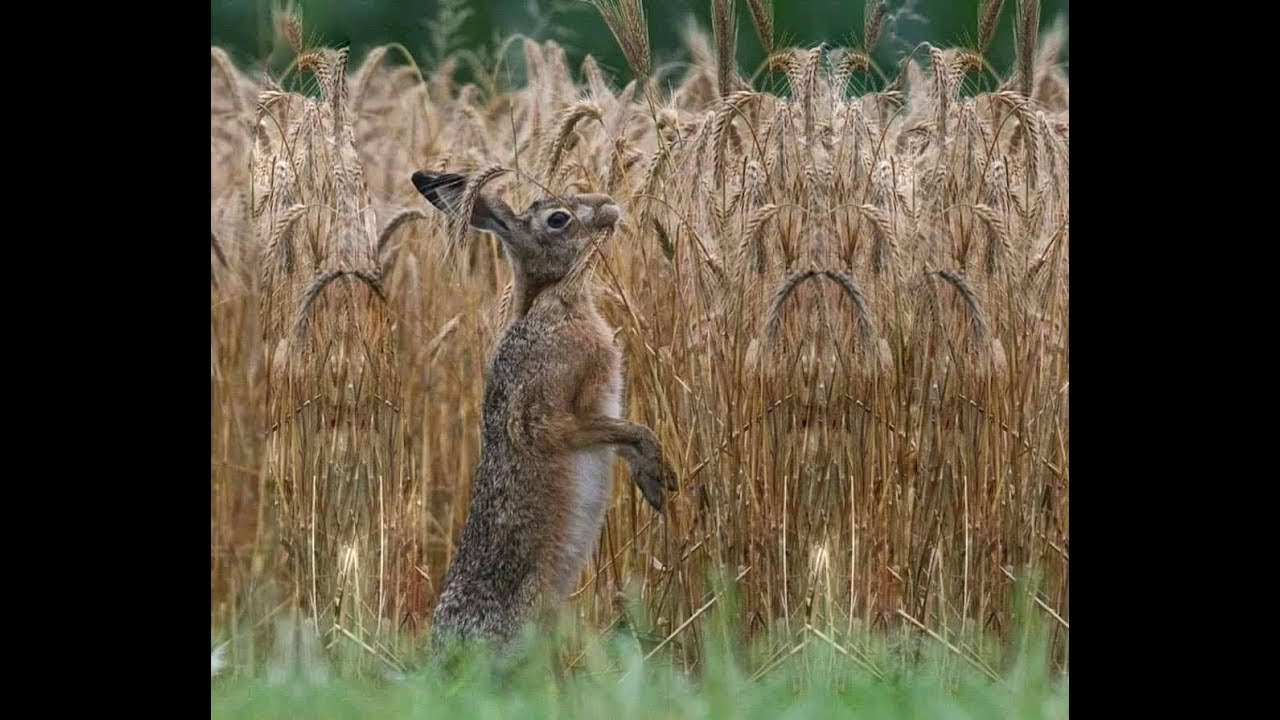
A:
[210,589,1069,720]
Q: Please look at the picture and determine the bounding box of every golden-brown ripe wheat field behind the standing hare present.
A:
[210,0,1070,669]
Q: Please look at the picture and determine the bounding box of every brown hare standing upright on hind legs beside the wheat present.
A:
[412,172,676,648]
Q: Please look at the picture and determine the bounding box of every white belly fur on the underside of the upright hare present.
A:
[559,386,622,594]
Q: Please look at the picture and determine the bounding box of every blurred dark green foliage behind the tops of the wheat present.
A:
[210,0,1070,90]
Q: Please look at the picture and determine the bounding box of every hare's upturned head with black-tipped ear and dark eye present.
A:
[413,172,622,286]
